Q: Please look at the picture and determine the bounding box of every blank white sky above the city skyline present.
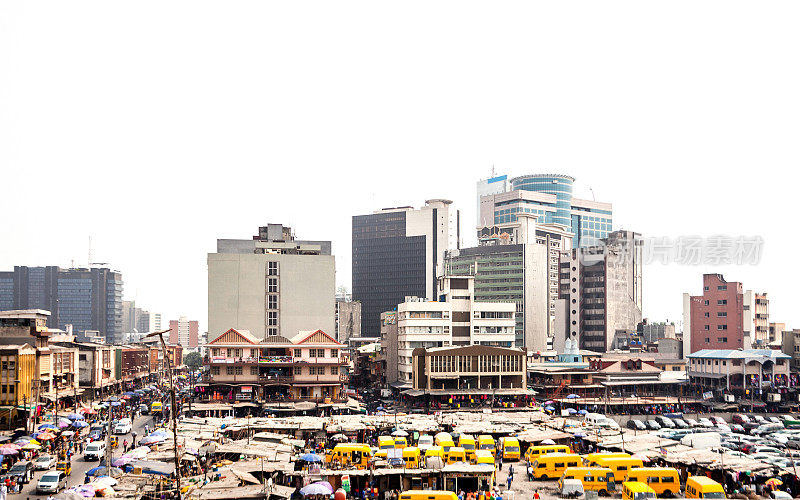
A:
[0,0,800,336]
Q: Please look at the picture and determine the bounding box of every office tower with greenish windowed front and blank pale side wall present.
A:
[446,214,572,352]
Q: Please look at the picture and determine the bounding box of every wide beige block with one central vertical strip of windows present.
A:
[208,224,336,339]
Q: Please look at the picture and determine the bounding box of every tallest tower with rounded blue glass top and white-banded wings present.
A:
[478,174,612,247]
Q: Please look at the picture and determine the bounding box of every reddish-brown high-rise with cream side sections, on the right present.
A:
[683,274,769,355]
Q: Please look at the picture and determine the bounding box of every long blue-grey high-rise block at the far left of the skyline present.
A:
[0,266,123,342]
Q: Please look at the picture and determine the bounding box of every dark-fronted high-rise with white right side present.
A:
[353,199,461,338]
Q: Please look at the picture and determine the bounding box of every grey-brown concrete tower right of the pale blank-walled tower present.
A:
[554,231,642,352]
